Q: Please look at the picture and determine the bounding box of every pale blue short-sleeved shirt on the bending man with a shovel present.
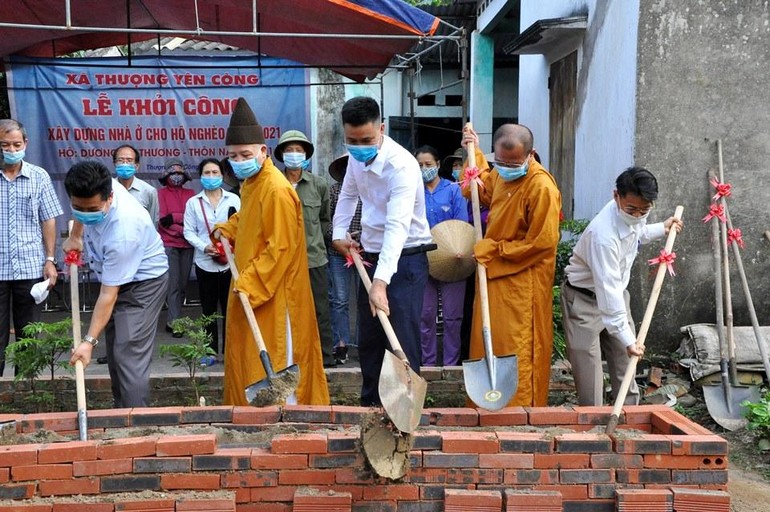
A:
[85,180,168,286]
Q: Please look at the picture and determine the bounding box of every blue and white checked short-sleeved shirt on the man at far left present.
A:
[0,161,63,281]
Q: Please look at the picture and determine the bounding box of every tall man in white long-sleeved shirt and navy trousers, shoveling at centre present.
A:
[332,96,435,406]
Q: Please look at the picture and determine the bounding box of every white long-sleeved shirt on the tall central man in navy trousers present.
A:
[332,135,433,284]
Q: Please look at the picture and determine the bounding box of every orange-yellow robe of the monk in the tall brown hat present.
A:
[216,158,329,405]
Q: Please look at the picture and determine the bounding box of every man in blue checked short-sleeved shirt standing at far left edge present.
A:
[0,119,62,377]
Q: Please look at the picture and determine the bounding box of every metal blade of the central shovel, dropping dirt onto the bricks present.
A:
[377,350,428,433]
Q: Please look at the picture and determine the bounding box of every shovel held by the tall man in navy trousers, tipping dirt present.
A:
[350,250,428,433]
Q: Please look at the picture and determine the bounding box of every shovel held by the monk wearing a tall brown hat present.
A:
[222,234,299,407]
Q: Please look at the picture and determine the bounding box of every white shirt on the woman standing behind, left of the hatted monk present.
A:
[184,189,241,272]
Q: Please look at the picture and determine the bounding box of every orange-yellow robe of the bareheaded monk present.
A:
[463,150,561,406]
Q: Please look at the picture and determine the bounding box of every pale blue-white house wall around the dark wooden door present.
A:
[519,0,639,218]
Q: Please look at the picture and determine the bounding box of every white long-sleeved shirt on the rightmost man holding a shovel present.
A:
[564,199,666,347]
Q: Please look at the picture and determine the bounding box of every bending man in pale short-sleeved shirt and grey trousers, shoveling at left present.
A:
[64,161,168,407]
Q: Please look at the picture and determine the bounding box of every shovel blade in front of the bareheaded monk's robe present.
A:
[463,354,519,411]
